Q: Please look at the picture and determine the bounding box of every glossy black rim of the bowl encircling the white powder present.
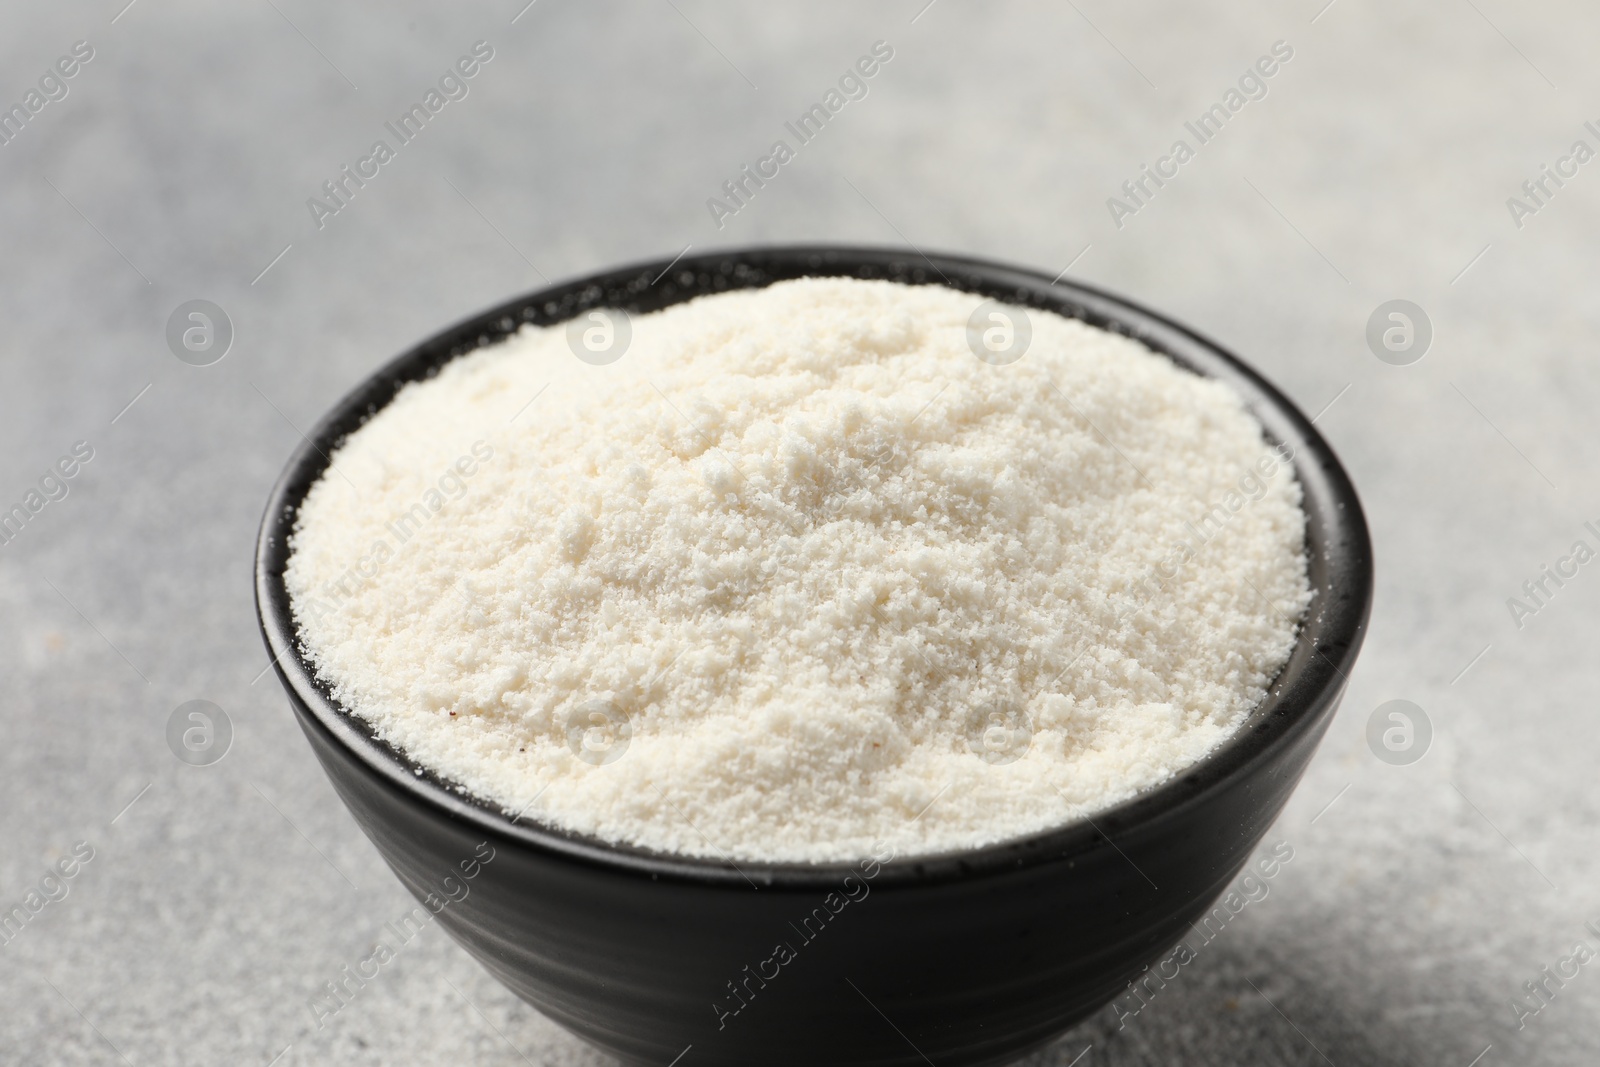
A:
[254,245,1373,889]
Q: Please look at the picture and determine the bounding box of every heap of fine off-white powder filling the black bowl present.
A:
[286,278,1310,861]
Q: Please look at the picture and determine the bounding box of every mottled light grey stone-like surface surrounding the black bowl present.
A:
[0,0,1600,1067]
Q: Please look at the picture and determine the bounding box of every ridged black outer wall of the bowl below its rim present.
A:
[296,675,1339,1067]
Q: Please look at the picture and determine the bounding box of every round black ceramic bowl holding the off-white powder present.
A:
[256,248,1373,1067]
